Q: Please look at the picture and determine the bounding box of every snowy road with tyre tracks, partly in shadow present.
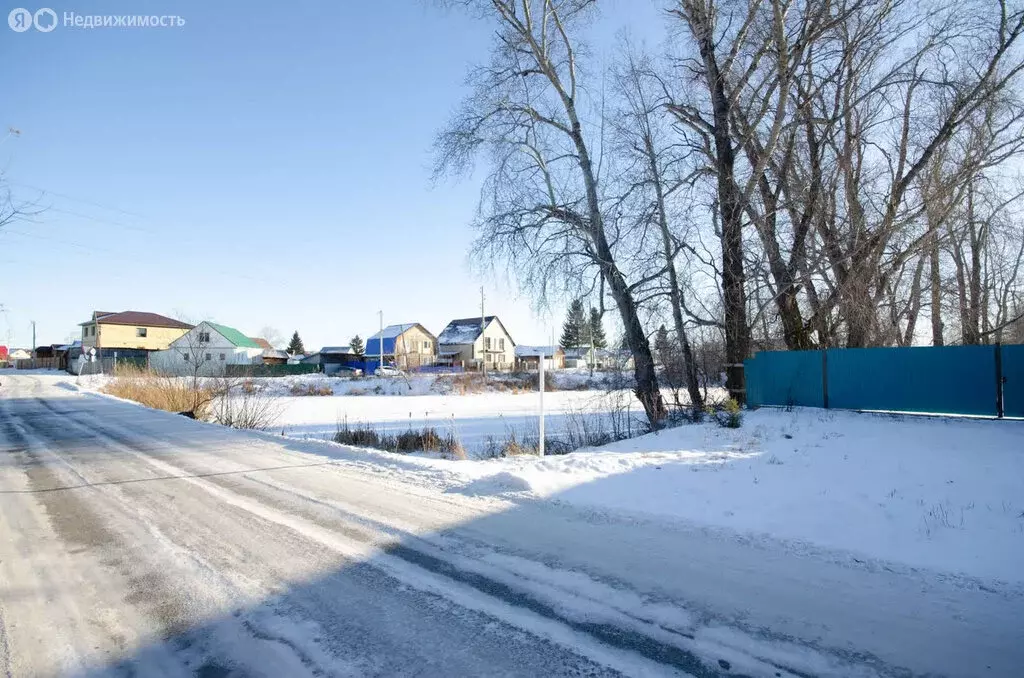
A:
[0,374,1024,677]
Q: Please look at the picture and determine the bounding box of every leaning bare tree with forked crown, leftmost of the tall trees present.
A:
[436,0,665,426]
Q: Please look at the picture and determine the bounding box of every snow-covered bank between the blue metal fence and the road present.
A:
[446,410,1024,581]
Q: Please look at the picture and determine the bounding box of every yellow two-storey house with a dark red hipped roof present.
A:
[81,310,191,355]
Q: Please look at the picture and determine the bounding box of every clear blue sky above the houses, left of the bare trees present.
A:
[0,0,664,347]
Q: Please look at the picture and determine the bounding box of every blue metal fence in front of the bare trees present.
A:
[744,344,1024,417]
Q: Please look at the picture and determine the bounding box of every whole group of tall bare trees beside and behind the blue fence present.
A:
[437,0,1024,422]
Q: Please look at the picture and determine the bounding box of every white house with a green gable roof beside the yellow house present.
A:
[150,321,263,377]
